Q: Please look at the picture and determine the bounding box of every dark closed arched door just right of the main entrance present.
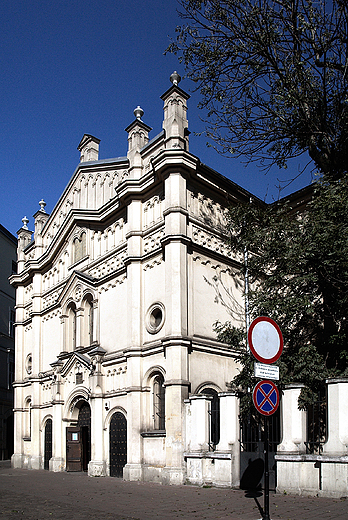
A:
[109,412,127,478]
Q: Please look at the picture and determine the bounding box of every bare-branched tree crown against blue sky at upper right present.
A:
[168,0,348,179]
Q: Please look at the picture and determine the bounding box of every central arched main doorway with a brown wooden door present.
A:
[66,401,91,471]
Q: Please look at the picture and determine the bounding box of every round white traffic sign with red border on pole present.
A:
[248,316,284,365]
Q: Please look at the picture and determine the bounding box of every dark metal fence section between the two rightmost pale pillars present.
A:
[305,387,327,454]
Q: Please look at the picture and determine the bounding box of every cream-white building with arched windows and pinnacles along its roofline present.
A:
[11,74,250,485]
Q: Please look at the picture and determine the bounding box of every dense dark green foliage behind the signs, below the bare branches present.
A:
[216,175,348,410]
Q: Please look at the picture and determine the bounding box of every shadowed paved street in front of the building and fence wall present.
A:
[0,463,348,520]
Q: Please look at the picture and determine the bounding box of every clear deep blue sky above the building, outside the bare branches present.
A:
[0,0,309,234]
